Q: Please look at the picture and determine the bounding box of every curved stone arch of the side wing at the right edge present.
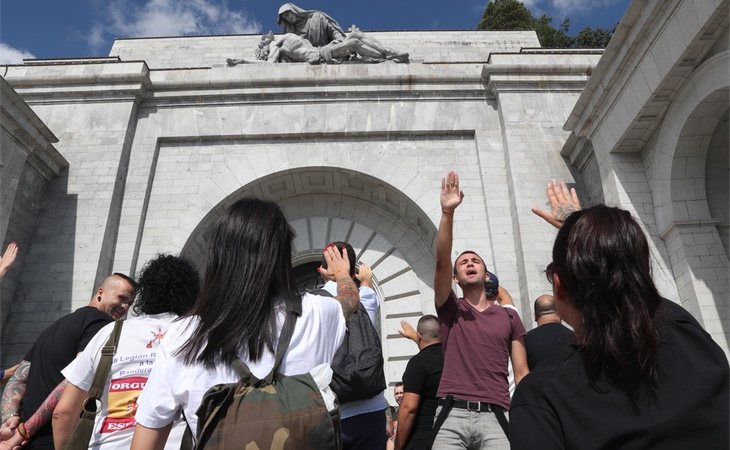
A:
[653,51,730,352]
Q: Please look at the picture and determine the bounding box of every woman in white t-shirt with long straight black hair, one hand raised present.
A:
[132,198,359,449]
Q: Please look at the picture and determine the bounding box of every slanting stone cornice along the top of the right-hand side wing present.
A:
[563,0,728,154]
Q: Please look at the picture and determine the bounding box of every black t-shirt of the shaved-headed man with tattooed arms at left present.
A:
[20,306,113,448]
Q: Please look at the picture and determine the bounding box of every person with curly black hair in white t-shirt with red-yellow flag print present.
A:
[53,255,200,450]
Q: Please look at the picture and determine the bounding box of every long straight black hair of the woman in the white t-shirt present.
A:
[179,198,296,368]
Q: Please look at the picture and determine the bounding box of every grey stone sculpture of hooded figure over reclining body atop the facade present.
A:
[226,3,408,65]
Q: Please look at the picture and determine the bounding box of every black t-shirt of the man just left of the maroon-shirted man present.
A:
[403,344,444,448]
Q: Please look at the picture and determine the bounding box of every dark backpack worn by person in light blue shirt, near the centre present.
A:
[310,289,385,403]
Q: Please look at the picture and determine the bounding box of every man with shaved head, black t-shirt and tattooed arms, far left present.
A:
[0,273,136,449]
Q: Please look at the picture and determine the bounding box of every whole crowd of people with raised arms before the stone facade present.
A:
[0,172,730,450]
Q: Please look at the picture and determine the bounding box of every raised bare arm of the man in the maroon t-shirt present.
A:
[433,172,464,308]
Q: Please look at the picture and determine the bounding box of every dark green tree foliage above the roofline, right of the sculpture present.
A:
[477,0,616,48]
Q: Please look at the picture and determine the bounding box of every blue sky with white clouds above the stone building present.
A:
[0,0,630,64]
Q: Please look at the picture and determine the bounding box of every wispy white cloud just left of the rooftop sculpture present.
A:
[86,0,262,50]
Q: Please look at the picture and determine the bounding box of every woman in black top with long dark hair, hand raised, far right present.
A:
[510,183,729,450]
